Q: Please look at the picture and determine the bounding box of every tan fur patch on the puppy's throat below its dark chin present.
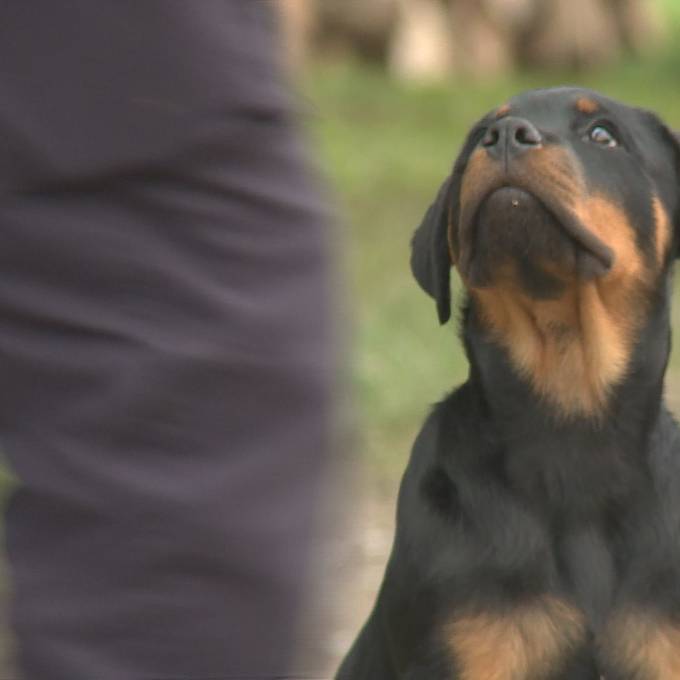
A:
[470,266,669,421]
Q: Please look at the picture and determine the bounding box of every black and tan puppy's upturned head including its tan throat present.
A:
[411,88,680,412]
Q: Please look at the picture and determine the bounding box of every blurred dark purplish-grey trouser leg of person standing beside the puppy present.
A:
[0,0,330,680]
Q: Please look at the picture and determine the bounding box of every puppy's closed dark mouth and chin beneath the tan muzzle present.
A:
[457,184,614,289]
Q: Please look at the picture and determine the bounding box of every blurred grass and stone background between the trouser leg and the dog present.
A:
[278,0,680,668]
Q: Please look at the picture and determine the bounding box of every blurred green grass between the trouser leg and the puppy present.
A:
[303,11,680,477]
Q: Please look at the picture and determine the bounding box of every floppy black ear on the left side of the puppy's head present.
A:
[411,177,452,324]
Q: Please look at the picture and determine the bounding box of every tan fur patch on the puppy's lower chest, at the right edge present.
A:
[599,611,680,680]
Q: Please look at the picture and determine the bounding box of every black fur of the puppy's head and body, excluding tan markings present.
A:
[337,88,680,680]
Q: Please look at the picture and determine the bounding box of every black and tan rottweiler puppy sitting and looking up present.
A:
[337,88,680,680]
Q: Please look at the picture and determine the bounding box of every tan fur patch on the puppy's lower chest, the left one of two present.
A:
[446,597,585,680]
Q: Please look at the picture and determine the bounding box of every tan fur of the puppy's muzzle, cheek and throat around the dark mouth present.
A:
[459,147,652,419]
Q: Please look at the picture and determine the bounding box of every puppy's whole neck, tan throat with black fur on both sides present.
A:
[463,277,671,432]
